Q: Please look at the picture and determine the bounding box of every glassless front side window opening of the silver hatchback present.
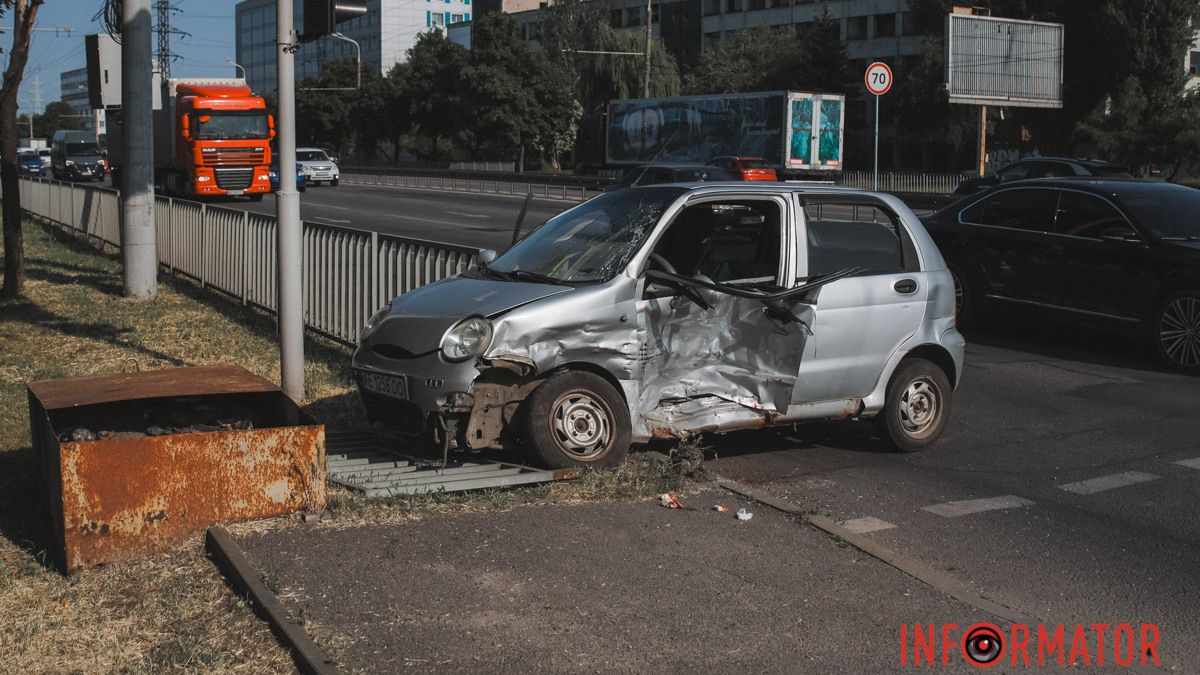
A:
[654,199,782,286]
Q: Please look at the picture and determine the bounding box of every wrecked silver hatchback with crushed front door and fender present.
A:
[353,183,964,467]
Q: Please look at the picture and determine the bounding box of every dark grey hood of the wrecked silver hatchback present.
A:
[362,276,572,356]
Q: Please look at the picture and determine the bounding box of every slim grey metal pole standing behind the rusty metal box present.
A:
[274,0,304,401]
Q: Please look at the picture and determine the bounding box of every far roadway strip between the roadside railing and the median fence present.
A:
[240,183,577,251]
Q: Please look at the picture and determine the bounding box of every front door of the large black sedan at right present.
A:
[1046,190,1150,323]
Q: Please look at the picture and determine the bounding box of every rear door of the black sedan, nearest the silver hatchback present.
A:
[958,187,1058,304]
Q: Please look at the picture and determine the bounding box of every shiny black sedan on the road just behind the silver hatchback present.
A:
[925,179,1200,375]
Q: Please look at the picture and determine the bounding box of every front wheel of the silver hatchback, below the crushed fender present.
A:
[524,371,631,468]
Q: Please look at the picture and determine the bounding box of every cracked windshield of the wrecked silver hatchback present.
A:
[487,187,685,283]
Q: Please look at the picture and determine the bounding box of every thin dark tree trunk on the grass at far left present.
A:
[0,0,42,298]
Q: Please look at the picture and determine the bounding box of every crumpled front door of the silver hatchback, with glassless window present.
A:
[638,196,811,413]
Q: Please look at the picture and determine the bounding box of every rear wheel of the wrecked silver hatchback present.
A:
[875,358,953,453]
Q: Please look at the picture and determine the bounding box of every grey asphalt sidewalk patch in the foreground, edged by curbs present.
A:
[241,488,991,673]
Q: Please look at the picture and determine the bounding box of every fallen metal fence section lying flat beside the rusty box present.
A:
[325,431,581,497]
